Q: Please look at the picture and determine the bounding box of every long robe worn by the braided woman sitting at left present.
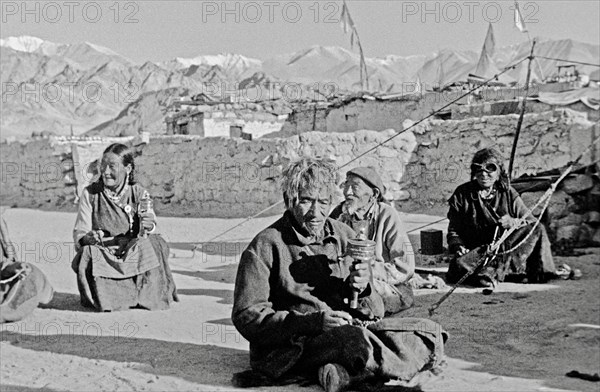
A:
[72,182,178,311]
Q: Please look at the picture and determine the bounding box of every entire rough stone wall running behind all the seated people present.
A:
[0,110,600,227]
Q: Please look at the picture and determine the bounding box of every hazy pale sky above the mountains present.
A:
[0,0,600,62]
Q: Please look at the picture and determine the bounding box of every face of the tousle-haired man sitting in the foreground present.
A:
[290,188,331,236]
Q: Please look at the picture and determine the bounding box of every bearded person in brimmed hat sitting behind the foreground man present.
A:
[330,167,415,313]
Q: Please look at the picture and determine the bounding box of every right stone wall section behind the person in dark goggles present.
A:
[400,109,600,206]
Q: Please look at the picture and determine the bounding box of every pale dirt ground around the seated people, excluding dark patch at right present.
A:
[0,209,600,392]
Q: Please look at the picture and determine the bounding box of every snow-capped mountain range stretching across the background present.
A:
[0,36,600,139]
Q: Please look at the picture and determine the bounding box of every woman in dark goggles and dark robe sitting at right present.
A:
[446,148,555,287]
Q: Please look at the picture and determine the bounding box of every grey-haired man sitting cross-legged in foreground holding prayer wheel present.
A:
[232,159,446,392]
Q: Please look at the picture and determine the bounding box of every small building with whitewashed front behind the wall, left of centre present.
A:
[165,94,291,140]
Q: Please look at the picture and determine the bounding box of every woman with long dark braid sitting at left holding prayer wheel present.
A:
[72,143,177,311]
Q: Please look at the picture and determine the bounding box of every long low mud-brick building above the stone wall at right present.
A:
[277,82,600,137]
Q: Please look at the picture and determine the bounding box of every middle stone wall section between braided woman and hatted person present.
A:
[137,130,416,217]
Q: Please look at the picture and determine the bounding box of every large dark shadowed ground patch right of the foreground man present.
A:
[403,255,600,391]
